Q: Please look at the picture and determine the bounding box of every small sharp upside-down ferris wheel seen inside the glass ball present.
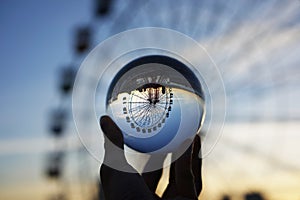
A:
[123,84,173,133]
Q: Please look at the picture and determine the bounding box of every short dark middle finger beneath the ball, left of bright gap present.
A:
[142,155,166,193]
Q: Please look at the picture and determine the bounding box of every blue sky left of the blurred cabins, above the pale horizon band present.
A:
[0,0,91,138]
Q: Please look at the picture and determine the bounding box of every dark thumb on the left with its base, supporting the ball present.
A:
[100,116,155,200]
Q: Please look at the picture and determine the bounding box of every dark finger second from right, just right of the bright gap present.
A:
[175,140,197,199]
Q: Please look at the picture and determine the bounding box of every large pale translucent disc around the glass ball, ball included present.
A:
[72,27,226,171]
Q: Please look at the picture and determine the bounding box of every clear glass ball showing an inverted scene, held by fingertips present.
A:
[106,55,205,153]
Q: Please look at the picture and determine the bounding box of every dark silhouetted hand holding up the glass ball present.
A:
[100,116,202,200]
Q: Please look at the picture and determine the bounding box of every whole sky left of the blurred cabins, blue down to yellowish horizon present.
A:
[0,0,90,199]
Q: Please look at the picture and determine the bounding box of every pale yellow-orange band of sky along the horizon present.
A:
[0,122,300,200]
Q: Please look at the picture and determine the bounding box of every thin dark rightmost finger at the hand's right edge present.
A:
[192,135,202,196]
